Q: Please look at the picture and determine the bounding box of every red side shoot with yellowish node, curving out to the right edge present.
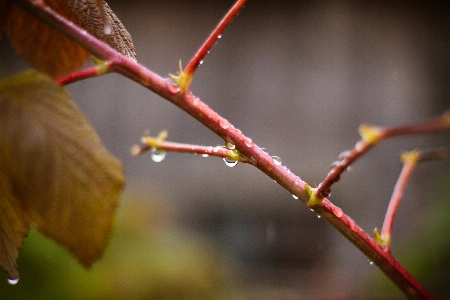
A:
[316,111,450,198]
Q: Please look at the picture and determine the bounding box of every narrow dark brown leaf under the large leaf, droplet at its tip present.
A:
[0,170,30,279]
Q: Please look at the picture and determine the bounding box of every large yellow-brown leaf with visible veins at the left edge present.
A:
[0,72,124,274]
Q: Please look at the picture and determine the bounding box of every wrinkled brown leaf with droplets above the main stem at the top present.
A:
[66,0,136,60]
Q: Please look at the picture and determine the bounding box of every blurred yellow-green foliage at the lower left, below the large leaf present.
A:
[0,195,230,300]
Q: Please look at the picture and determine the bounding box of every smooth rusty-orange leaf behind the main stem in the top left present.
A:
[7,0,90,78]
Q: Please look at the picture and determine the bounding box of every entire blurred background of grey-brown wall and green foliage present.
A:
[0,0,450,299]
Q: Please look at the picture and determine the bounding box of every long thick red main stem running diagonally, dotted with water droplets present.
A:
[13,0,450,299]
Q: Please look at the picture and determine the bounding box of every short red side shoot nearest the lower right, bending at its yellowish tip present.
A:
[374,148,445,253]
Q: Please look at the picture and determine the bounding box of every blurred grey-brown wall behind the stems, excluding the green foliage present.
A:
[2,1,450,297]
